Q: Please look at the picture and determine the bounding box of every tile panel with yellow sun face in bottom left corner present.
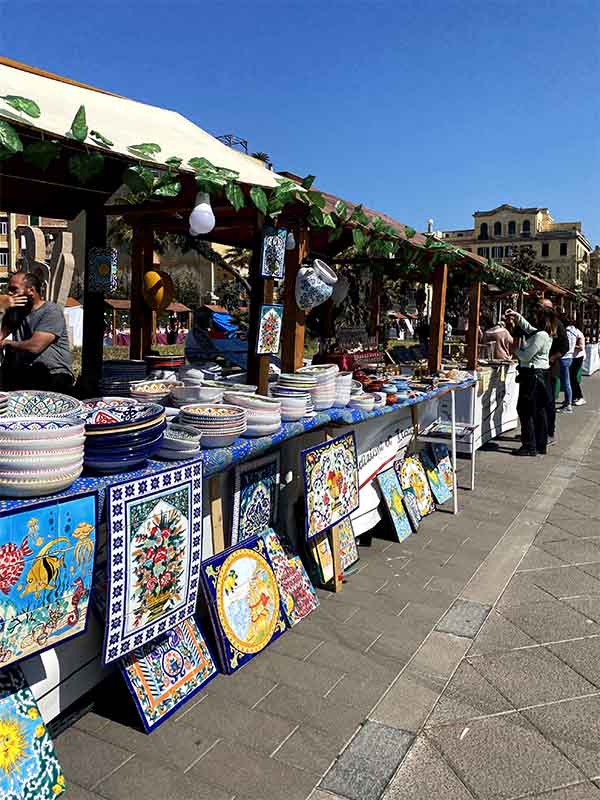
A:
[0,666,66,800]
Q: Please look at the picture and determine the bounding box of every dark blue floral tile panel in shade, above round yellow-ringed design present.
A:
[231,453,280,544]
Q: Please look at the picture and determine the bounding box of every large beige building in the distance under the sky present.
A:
[438,204,599,289]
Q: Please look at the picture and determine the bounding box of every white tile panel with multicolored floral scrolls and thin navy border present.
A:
[301,433,359,539]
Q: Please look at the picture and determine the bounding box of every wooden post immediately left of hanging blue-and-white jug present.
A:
[281,228,308,372]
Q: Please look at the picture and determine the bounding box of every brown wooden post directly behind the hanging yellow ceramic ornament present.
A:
[129,223,154,359]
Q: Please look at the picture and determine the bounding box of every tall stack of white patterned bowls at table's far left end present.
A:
[0,417,85,497]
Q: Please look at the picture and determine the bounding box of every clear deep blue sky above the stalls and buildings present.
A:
[0,0,600,244]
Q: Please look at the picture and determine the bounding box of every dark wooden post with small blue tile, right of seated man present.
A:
[81,206,106,397]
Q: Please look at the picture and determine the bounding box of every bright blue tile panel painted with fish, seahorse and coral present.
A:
[0,492,97,668]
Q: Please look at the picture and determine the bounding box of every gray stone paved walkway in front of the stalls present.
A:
[56,379,600,800]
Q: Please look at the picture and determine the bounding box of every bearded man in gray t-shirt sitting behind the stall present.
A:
[0,272,73,392]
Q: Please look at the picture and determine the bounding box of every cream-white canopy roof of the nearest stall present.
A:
[0,58,279,187]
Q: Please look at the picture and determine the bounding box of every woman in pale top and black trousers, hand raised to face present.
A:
[507,306,557,456]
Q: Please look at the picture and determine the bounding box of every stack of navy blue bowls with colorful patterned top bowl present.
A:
[82,397,165,472]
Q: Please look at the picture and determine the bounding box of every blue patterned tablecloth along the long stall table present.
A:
[0,380,475,511]
